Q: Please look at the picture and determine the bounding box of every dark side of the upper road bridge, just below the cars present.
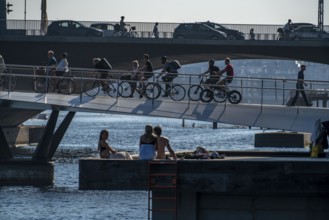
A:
[0,36,329,69]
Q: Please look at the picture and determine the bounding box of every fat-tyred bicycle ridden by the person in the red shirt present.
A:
[200,79,242,104]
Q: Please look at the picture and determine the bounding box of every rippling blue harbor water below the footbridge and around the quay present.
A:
[0,112,306,220]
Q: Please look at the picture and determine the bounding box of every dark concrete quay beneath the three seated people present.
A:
[79,152,329,220]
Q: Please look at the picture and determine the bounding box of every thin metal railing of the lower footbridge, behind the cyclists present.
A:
[0,65,329,108]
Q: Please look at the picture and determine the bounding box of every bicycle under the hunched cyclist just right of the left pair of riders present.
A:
[83,76,119,97]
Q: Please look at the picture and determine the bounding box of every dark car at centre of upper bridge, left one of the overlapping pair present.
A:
[173,23,227,40]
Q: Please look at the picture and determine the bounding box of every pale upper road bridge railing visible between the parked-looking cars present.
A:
[0,20,329,40]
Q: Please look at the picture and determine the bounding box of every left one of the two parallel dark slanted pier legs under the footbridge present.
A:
[32,110,59,160]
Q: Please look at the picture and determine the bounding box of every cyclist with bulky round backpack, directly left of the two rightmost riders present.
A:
[157,56,181,97]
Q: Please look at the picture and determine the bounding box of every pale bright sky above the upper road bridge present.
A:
[7,0,329,25]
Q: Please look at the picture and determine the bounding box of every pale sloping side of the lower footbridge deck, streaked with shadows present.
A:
[0,92,329,132]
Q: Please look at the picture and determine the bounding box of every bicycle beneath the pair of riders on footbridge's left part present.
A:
[33,71,75,95]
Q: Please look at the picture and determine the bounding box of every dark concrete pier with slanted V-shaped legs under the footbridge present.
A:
[0,110,75,186]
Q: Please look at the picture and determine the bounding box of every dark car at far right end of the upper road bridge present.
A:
[289,26,329,40]
